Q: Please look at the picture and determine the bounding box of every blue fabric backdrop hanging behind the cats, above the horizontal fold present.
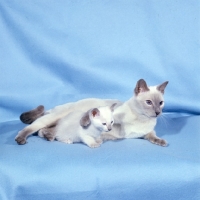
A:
[0,0,200,121]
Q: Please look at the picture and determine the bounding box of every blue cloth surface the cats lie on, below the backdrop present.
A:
[0,116,200,200]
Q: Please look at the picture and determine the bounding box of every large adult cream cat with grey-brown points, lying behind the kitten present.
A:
[15,79,168,146]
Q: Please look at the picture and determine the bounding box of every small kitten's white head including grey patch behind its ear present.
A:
[80,103,116,132]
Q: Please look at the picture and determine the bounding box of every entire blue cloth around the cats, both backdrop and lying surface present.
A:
[0,0,200,200]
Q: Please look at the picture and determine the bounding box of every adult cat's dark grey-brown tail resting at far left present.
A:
[19,105,44,124]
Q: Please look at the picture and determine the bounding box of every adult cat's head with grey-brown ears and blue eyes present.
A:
[134,79,168,117]
